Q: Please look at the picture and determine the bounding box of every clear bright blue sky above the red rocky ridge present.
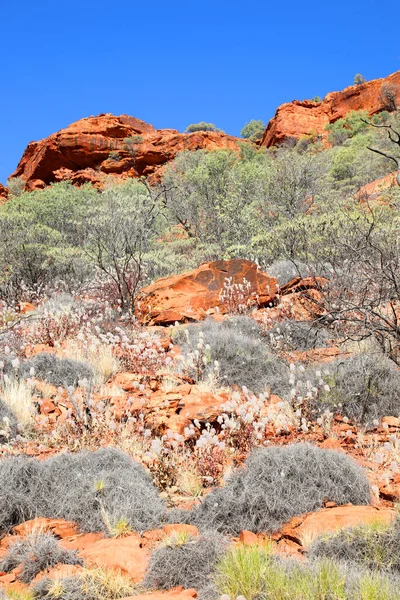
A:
[0,0,400,183]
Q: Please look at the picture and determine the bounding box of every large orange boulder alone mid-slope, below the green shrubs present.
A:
[134,259,278,325]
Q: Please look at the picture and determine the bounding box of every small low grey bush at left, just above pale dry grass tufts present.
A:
[21,352,94,387]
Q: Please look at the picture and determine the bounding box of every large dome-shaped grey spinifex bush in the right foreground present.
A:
[191,444,371,533]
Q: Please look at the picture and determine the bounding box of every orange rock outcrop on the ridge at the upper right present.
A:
[261,71,400,148]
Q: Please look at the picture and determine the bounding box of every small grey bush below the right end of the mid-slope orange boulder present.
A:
[268,320,331,351]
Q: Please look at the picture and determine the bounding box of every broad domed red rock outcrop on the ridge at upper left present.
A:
[10,114,244,188]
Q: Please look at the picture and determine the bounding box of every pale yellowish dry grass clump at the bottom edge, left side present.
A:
[31,569,135,600]
